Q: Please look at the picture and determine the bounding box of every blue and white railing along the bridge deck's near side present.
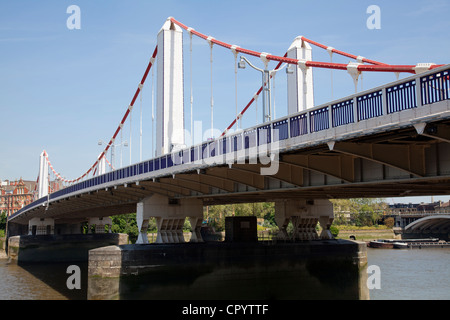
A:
[10,65,450,219]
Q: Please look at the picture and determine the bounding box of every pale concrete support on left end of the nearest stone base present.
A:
[136,194,203,244]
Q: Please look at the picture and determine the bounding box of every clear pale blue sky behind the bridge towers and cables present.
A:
[0,0,450,202]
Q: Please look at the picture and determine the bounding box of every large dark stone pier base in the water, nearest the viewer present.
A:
[88,240,369,300]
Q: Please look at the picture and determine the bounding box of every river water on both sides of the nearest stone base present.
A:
[0,248,450,300]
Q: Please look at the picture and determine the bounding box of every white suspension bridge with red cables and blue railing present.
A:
[8,17,450,243]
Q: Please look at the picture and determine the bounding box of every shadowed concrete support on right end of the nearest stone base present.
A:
[275,199,334,240]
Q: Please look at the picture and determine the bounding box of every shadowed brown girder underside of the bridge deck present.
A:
[14,120,450,224]
